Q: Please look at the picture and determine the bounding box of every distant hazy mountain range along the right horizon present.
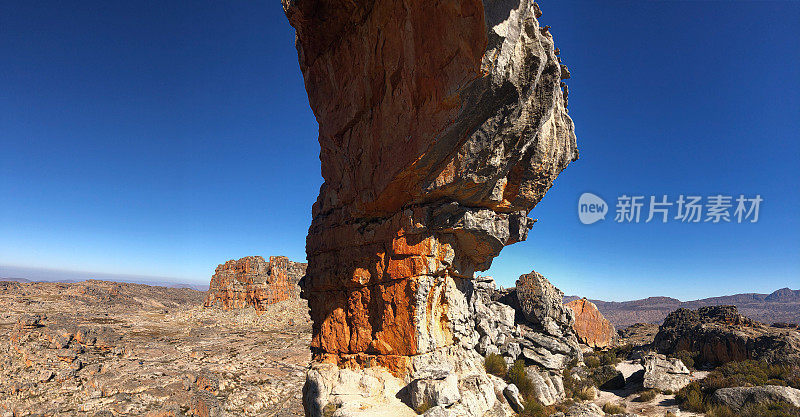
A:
[564,288,800,328]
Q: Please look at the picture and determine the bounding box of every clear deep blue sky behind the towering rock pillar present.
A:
[0,0,800,300]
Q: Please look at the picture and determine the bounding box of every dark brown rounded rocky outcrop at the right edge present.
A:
[653,306,800,365]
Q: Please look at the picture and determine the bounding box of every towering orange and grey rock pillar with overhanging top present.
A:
[283,0,577,415]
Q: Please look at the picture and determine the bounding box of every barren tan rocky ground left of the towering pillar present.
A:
[0,281,310,417]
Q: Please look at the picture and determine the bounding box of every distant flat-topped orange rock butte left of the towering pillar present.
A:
[204,256,305,311]
